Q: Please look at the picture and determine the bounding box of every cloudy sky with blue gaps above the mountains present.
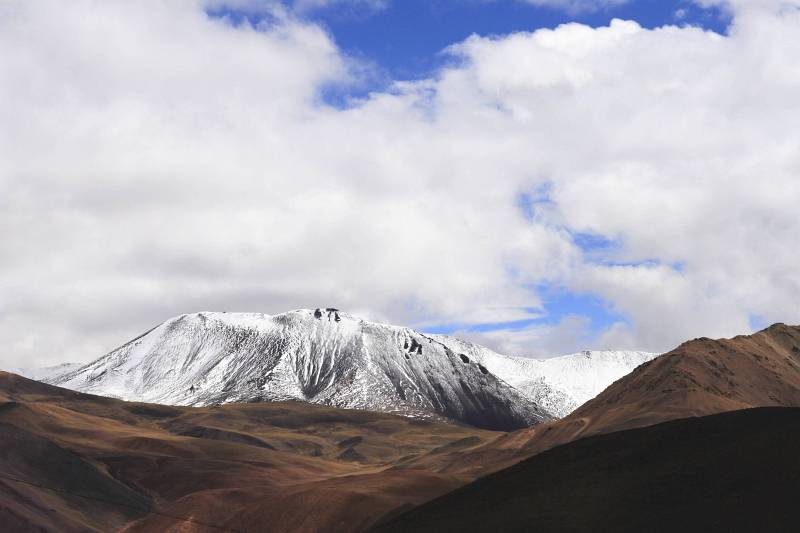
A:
[0,0,800,368]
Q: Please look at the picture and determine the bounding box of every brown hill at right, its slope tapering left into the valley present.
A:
[404,324,800,472]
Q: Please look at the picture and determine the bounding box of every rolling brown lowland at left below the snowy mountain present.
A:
[0,372,498,532]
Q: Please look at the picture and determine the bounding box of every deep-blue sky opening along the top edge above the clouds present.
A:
[206,0,730,109]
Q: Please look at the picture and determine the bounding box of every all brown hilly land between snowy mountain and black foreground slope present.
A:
[0,324,800,532]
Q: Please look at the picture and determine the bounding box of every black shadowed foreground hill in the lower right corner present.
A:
[375,408,800,533]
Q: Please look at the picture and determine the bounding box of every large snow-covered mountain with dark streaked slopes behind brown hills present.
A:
[34,310,551,430]
